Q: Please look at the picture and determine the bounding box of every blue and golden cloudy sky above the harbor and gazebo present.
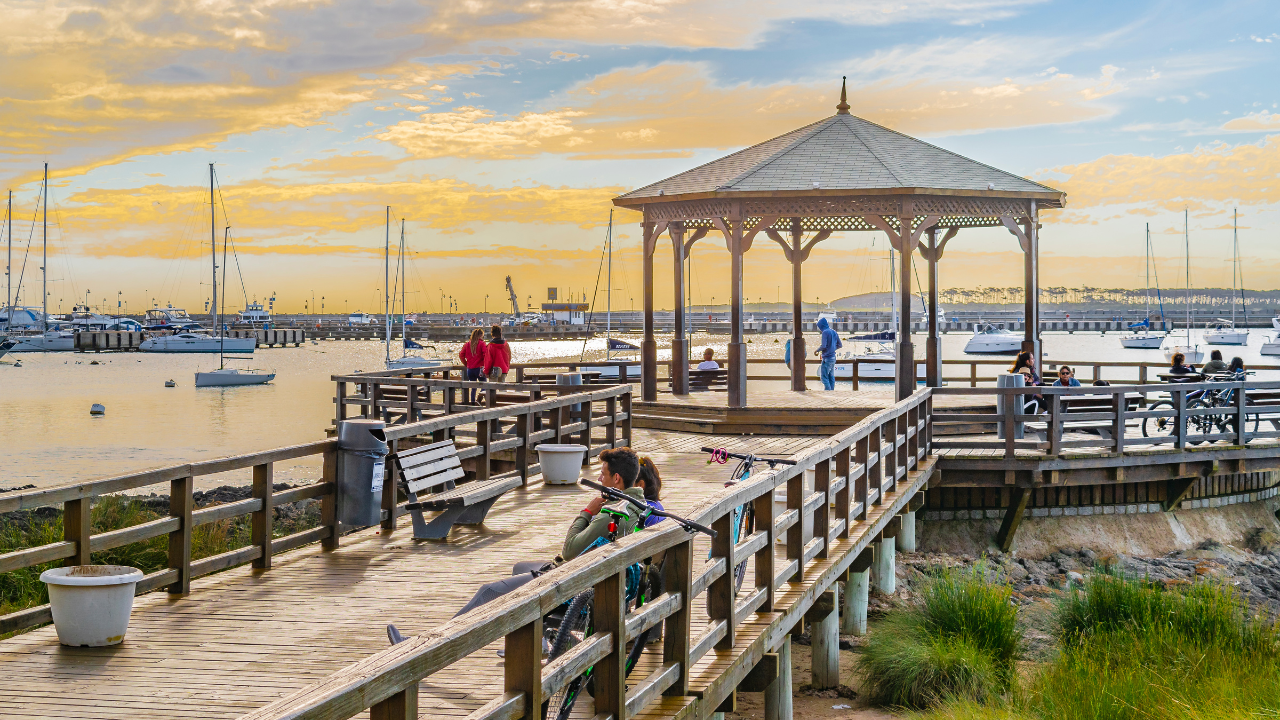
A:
[0,0,1280,313]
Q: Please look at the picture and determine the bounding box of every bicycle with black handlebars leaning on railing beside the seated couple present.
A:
[543,480,716,720]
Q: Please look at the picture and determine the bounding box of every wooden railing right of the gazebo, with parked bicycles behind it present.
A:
[933,380,1280,459]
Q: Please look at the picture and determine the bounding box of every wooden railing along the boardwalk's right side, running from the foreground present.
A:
[244,389,932,720]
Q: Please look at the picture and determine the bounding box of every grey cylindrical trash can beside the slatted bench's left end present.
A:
[338,419,387,528]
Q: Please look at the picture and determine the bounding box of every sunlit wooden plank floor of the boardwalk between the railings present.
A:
[0,430,819,720]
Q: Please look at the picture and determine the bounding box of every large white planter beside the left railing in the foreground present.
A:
[40,565,142,647]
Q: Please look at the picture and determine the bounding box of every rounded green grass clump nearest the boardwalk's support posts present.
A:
[859,568,1021,708]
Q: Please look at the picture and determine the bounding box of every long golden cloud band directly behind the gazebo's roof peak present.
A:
[376,63,1106,159]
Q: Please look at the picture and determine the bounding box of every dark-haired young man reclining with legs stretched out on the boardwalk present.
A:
[454,447,645,618]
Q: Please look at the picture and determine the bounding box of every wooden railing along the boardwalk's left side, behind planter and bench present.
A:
[0,380,631,634]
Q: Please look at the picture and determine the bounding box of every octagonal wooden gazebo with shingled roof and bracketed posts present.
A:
[613,79,1065,407]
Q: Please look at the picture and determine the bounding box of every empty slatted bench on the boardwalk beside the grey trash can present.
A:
[392,439,522,539]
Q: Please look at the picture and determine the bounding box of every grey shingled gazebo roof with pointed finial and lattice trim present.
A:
[613,81,1065,229]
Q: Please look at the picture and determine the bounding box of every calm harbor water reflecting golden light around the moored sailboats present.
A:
[0,331,1280,488]
